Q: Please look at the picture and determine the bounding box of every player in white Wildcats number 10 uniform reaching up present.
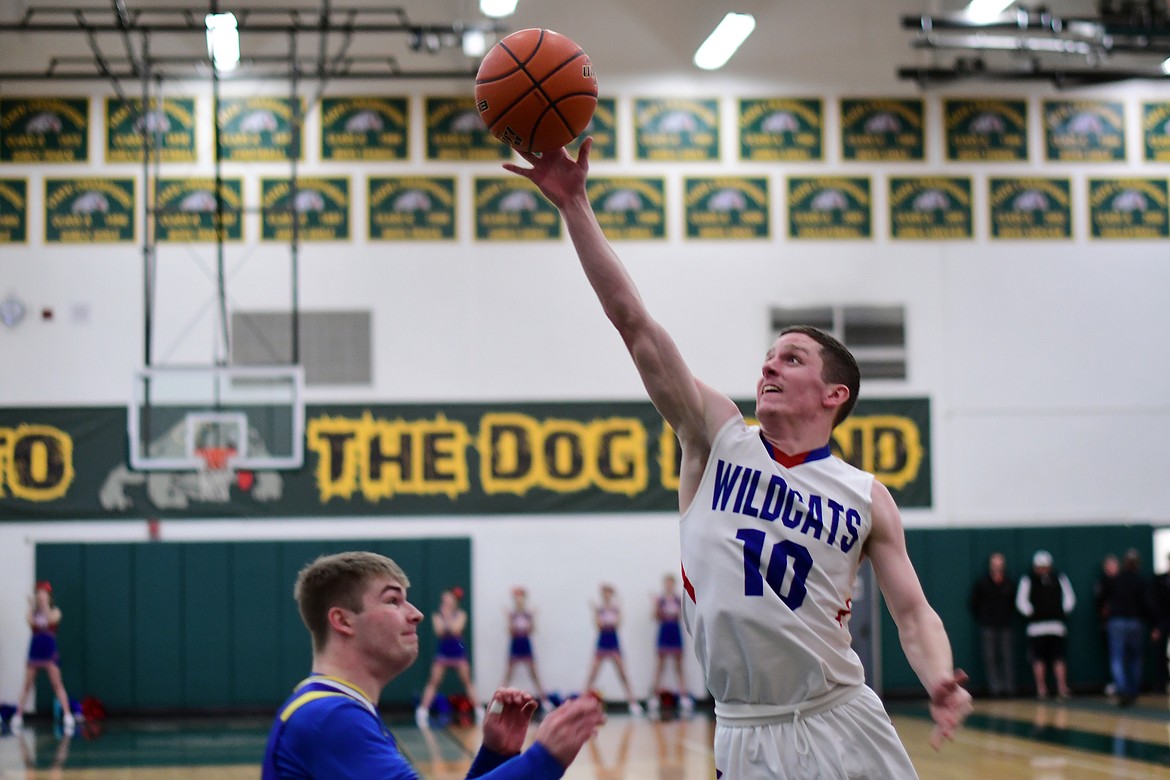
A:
[504,139,971,780]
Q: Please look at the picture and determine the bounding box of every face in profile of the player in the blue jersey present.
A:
[353,577,422,679]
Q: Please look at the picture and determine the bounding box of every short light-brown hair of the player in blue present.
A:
[293,552,411,653]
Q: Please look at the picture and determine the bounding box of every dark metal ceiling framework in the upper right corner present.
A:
[897,0,1170,88]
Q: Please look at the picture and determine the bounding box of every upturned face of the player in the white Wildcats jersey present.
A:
[756,333,830,417]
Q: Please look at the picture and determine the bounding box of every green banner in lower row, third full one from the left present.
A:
[260,177,350,242]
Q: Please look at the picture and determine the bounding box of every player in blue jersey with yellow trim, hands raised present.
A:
[261,552,605,780]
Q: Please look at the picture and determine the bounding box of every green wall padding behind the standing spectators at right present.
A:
[881,525,1154,696]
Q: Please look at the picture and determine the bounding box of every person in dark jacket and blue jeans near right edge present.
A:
[1096,550,1150,706]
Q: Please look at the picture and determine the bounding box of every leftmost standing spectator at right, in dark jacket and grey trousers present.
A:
[968,552,1016,697]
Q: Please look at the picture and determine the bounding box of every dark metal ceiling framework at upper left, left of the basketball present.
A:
[0,0,503,83]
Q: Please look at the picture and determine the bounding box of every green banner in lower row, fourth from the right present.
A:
[787,177,873,240]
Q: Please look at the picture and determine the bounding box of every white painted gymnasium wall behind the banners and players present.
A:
[0,0,1170,700]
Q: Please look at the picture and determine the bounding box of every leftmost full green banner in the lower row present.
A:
[44,178,135,243]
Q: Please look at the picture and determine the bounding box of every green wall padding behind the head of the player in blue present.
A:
[36,538,474,711]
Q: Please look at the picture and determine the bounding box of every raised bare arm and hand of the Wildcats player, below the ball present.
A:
[504,138,738,447]
